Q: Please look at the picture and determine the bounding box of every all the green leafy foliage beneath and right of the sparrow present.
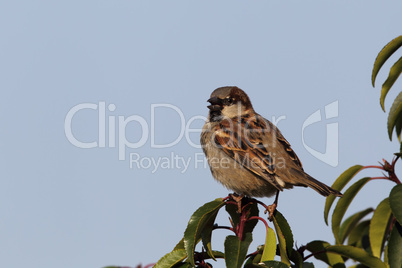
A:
[110,36,402,268]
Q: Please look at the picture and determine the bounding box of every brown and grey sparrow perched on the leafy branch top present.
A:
[201,86,342,219]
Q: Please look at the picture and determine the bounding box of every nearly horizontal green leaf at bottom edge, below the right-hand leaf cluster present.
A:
[327,245,386,268]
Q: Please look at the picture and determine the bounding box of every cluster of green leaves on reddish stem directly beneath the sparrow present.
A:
[155,196,296,268]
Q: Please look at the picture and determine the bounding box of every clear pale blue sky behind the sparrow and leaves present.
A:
[0,0,402,268]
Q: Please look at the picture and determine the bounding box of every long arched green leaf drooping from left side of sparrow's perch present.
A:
[184,198,225,266]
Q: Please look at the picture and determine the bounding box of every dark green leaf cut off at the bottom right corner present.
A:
[388,222,402,267]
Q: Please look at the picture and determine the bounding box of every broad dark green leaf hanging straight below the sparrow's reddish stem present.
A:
[224,233,253,268]
